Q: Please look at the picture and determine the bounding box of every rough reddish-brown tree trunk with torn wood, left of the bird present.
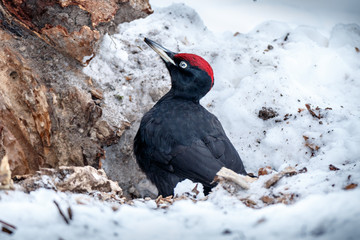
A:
[0,0,152,189]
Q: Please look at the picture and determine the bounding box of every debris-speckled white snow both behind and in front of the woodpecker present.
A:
[0,1,360,239]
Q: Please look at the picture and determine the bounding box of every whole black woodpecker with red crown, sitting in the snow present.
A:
[134,39,246,196]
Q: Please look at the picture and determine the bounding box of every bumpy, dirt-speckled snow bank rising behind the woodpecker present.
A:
[85,4,360,194]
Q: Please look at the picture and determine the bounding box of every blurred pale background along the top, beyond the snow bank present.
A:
[150,0,360,33]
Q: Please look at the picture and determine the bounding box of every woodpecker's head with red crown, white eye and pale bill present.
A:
[144,38,214,101]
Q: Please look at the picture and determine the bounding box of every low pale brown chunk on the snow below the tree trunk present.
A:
[19,166,122,196]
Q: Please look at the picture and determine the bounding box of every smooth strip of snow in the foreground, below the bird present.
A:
[0,189,360,240]
